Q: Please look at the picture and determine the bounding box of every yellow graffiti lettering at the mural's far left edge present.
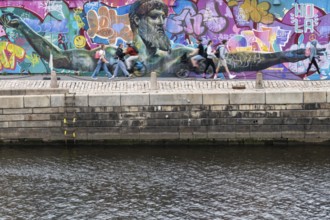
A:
[0,41,25,70]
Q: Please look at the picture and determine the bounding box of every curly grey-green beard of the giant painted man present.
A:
[138,18,171,51]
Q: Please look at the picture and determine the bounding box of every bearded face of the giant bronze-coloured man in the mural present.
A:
[138,9,171,51]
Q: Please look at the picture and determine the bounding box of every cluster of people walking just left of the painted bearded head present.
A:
[92,42,139,80]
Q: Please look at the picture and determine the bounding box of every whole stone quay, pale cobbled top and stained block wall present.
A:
[0,75,330,142]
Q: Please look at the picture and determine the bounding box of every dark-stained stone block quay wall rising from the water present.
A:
[0,90,330,142]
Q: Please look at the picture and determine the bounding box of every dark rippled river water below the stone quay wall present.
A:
[0,146,330,220]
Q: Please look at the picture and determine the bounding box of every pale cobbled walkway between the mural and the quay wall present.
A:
[0,75,330,93]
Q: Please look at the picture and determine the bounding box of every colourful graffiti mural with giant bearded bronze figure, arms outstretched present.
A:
[0,0,330,80]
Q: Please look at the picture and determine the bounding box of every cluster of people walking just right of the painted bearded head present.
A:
[190,39,236,79]
